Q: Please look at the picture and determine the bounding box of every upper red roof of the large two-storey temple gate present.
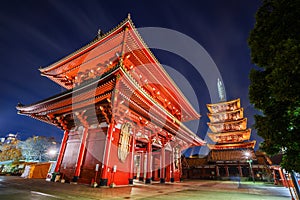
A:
[40,17,200,121]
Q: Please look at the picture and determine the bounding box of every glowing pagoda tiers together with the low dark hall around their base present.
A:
[184,95,271,180]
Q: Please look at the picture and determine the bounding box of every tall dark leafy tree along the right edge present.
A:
[248,0,300,172]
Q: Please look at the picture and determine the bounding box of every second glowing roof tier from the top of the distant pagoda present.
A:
[207,108,244,123]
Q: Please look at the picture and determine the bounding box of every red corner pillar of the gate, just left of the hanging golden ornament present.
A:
[100,122,114,186]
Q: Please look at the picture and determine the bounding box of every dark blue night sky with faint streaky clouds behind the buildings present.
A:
[0,0,262,153]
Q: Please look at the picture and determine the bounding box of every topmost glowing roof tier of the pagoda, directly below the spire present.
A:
[206,98,241,113]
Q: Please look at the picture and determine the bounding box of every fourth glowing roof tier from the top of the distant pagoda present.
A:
[208,129,251,144]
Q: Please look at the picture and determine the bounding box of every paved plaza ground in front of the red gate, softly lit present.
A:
[0,176,291,200]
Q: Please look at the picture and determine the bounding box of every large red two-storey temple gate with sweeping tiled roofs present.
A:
[17,16,205,186]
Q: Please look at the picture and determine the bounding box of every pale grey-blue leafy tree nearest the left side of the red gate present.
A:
[19,136,58,162]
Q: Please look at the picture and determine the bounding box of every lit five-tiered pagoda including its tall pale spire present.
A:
[207,79,256,176]
